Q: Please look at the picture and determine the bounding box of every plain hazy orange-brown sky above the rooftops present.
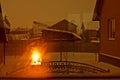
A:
[0,0,96,27]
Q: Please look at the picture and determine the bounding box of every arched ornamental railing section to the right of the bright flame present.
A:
[42,61,110,73]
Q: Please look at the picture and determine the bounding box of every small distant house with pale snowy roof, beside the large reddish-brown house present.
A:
[80,21,99,42]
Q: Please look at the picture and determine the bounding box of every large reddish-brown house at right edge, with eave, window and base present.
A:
[93,0,120,67]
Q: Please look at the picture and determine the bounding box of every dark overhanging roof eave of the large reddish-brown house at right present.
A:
[93,0,104,21]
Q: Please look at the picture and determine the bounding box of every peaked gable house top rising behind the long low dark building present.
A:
[49,19,77,33]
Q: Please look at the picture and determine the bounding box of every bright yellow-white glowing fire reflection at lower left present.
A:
[31,50,42,65]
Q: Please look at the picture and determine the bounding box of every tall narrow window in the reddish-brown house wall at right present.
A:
[108,18,115,40]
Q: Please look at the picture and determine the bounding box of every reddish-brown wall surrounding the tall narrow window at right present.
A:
[100,0,120,57]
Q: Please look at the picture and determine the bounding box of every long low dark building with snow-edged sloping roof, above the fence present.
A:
[42,29,81,40]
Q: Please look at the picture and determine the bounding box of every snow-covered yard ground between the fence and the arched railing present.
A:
[0,52,120,76]
